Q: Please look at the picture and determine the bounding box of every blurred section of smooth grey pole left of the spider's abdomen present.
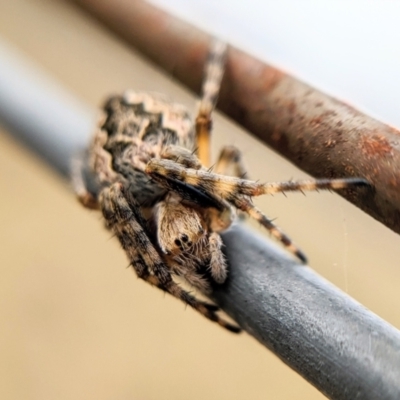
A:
[0,42,95,176]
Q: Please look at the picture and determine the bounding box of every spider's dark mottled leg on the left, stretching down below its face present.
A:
[99,183,240,332]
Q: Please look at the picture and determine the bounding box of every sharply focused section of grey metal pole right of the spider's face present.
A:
[219,227,400,400]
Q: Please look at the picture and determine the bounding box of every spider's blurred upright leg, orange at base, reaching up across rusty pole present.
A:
[196,41,227,166]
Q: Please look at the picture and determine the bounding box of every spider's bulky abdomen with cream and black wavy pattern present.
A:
[90,91,195,206]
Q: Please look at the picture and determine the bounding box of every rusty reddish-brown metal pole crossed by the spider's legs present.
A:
[73,0,400,233]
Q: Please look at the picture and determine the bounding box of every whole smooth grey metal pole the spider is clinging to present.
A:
[0,39,400,400]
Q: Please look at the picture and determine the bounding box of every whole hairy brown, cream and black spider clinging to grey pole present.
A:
[72,41,368,332]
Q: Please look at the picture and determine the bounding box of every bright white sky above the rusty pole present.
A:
[151,0,400,128]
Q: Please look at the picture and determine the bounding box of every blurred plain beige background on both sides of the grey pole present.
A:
[0,0,400,399]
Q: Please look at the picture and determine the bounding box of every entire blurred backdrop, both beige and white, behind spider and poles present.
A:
[0,0,400,400]
